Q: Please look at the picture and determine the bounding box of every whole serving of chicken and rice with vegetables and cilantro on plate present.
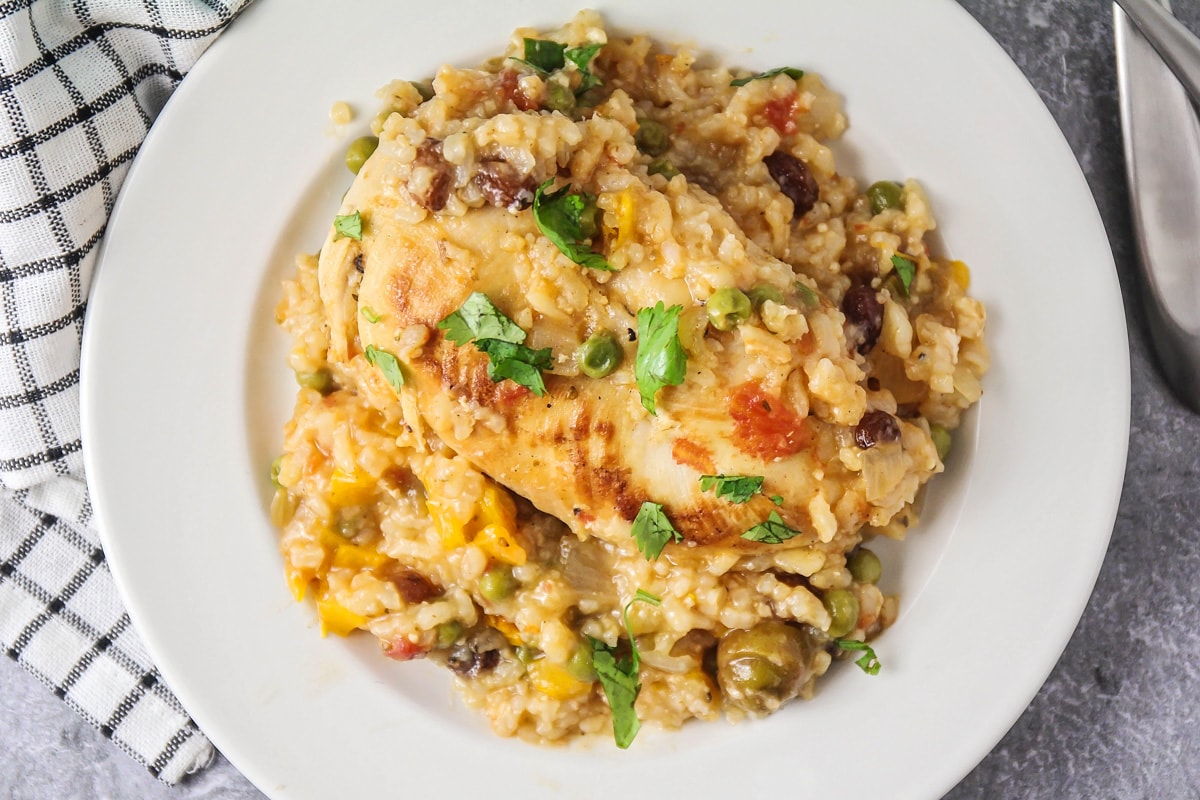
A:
[272,12,988,747]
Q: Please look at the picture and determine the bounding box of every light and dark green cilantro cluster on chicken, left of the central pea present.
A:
[438,291,553,397]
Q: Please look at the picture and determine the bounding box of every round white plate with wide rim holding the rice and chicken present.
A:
[83,0,1129,800]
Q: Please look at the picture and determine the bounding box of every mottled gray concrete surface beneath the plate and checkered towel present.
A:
[0,0,1200,800]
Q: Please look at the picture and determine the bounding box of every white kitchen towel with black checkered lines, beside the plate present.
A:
[0,0,248,783]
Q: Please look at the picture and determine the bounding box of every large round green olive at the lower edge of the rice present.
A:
[716,620,817,716]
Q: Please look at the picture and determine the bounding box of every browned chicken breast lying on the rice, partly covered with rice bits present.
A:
[319,103,941,548]
